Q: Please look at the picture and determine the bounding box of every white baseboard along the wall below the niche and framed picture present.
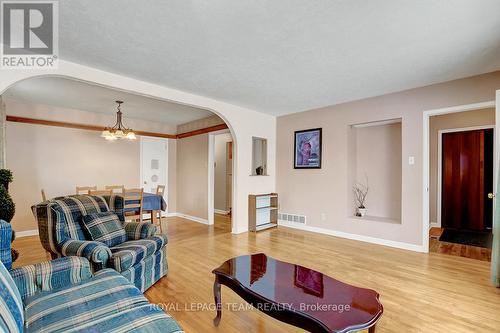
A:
[278,220,427,252]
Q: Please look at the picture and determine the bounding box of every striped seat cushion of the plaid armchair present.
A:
[108,235,167,272]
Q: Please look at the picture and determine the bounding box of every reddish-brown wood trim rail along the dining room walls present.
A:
[6,116,228,139]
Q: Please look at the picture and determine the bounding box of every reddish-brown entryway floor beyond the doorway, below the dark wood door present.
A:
[429,228,491,262]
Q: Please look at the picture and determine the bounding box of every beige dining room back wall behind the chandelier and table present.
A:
[6,99,175,231]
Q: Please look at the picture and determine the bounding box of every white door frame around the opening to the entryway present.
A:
[422,100,500,252]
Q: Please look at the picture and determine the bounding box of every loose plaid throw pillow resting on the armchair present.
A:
[82,212,127,247]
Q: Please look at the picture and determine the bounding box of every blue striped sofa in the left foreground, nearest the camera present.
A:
[0,220,183,333]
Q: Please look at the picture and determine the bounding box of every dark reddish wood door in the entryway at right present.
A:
[441,129,493,231]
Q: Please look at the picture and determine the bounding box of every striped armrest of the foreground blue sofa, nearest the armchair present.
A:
[10,257,92,301]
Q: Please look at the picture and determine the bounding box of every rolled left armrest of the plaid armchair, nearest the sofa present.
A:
[61,239,111,267]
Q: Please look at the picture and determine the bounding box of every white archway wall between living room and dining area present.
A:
[0,60,276,233]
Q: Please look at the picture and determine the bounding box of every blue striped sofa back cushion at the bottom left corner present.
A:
[0,261,24,332]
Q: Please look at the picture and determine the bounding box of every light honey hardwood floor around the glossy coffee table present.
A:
[10,218,500,333]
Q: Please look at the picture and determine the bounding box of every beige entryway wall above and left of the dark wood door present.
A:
[429,108,495,223]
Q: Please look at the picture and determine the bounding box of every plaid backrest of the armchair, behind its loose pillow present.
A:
[51,195,109,240]
